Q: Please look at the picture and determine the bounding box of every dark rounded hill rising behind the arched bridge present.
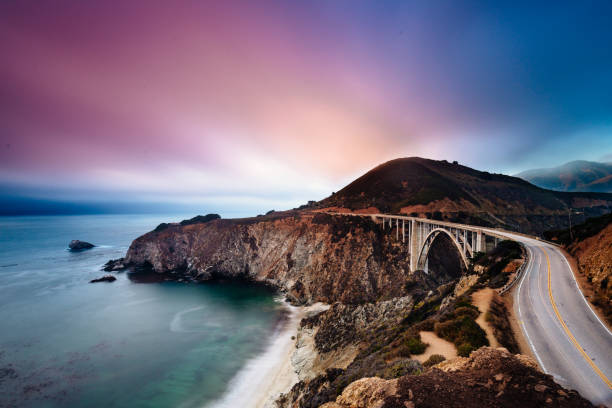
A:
[317,157,612,234]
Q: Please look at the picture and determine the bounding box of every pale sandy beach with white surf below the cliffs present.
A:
[205,301,307,408]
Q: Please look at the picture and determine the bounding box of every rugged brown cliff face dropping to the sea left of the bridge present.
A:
[125,213,435,303]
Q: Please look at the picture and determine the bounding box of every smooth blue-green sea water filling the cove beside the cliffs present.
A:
[0,215,283,408]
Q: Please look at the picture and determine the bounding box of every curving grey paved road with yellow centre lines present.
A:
[488,231,612,407]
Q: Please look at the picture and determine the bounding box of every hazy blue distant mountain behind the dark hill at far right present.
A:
[516,160,612,193]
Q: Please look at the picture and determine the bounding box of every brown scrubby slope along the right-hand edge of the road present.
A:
[545,214,612,324]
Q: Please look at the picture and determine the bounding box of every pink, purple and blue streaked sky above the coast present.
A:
[0,0,612,214]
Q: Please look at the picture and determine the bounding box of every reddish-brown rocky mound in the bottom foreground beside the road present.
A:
[321,347,592,408]
